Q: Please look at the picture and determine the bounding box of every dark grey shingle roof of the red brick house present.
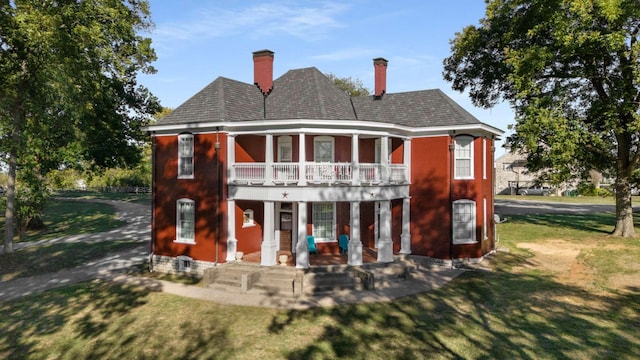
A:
[156,67,481,127]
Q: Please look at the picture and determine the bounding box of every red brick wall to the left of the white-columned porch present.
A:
[152,134,227,262]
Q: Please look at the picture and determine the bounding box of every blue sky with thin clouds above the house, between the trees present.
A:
[140,0,514,157]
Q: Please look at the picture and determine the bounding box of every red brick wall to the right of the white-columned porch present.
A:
[410,136,494,259]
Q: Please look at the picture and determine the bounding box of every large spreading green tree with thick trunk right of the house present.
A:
[444,0,640,236]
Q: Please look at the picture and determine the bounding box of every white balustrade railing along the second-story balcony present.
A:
[229,162,409,185]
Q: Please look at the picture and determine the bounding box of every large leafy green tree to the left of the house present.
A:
[0,0,159,252]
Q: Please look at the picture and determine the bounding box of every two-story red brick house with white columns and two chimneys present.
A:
[148,50,502,273]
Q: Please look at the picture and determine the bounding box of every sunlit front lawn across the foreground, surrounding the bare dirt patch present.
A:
[0,198,640,359]
